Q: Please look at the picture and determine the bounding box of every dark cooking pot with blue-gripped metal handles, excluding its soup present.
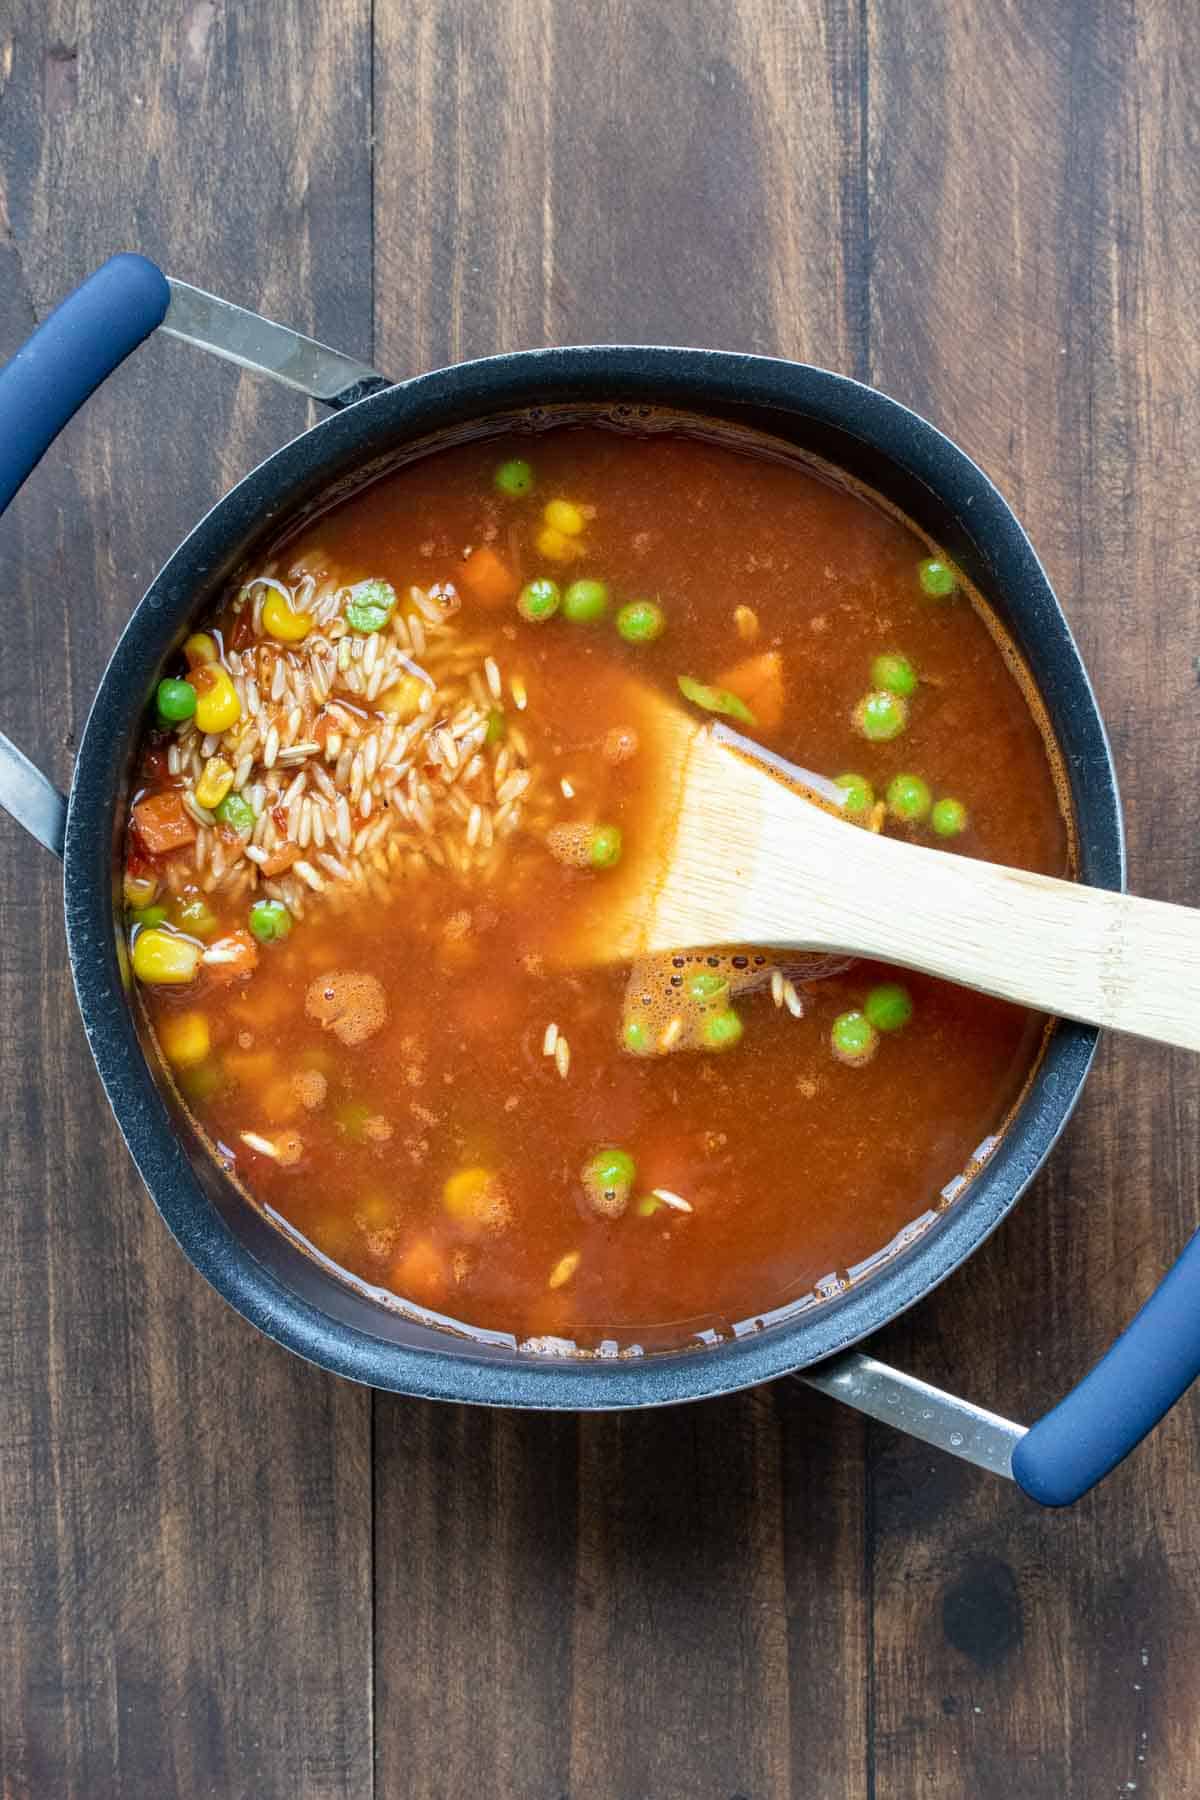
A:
[0,256,1200,1505]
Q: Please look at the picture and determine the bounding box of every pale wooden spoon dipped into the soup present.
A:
[561,688,1200,1049]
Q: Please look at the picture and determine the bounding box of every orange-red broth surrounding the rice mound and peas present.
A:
[130,427,1070,1348]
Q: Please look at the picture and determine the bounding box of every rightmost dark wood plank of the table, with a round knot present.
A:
[869,0,1200,1800]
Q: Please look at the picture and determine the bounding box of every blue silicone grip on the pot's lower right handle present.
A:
[1013,1231,1200,1507]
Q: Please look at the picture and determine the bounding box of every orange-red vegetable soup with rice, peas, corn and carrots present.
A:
[124,425,1072,1352]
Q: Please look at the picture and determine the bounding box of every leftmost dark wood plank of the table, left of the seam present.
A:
[0,0,372,1800]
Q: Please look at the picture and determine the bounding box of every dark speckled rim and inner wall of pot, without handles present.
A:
[63,346,1124,1409]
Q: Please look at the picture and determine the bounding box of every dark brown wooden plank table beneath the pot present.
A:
[0,0,1200,1800]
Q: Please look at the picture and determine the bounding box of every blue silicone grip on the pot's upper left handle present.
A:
[0,256,171,513]
